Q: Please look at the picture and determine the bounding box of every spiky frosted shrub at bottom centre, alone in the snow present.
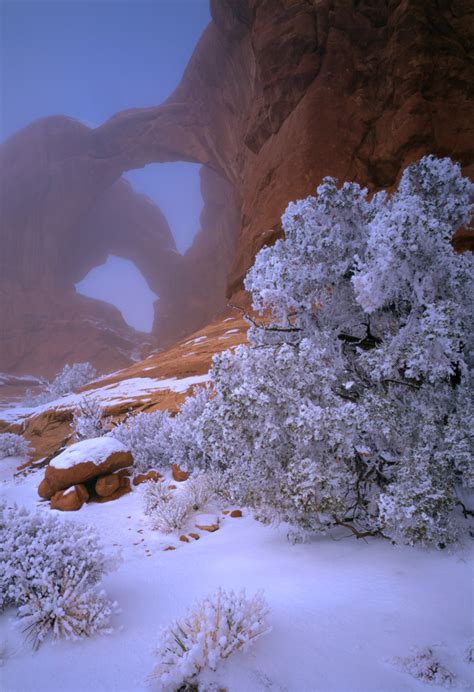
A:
[151,589,270,689]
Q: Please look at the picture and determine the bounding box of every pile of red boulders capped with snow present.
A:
[38,437,133,511]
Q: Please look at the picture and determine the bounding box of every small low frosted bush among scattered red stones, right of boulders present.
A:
[144,481,193,533]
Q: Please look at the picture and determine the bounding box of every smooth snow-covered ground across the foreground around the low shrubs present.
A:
[0,459,474,692]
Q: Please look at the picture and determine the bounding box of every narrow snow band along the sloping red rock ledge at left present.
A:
[0,374,209,423]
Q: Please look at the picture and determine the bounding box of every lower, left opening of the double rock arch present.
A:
[75,255,158,333]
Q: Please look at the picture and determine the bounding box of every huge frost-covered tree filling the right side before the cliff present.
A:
[168,157,474,547]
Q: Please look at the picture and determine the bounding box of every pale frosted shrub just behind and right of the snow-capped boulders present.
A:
[110,411,171,473]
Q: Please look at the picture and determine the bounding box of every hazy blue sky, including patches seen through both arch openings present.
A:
[0,0,210,331]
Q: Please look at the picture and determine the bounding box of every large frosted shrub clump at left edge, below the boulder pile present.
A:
[0,505,115,648]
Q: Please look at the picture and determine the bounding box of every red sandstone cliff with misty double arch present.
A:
[0,0,474,376]
